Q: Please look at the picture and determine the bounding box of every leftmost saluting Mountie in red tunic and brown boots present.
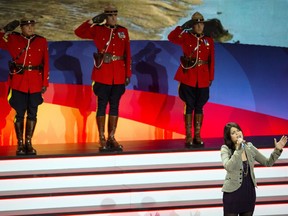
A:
[0,18,49,155]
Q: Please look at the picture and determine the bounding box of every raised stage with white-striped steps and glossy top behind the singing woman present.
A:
[0,136,288,216]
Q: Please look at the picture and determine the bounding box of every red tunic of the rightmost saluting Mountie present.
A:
[168,26,215,88]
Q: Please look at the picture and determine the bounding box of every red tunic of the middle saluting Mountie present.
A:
[75,21,131,85]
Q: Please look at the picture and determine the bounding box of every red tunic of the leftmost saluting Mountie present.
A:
[0,32,49,93]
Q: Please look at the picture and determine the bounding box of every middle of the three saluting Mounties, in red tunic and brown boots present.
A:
[75,4,132,152]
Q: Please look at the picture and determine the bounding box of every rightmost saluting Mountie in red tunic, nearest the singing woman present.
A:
[168,12,215,148]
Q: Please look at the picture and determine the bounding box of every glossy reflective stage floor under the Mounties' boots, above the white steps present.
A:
[0,136,280,159]
